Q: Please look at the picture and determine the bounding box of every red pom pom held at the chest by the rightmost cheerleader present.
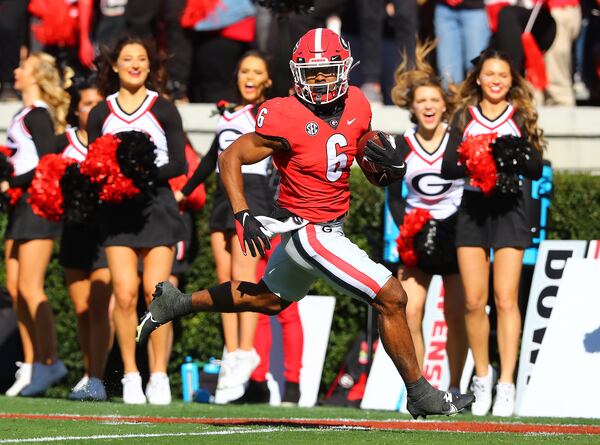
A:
[458,133,497,196]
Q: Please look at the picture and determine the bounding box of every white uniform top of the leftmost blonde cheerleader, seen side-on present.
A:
[6,100,48,176]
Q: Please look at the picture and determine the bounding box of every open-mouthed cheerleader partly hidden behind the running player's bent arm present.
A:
[175,51,273,396]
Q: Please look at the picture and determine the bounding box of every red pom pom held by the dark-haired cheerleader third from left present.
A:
[80,134,140,204]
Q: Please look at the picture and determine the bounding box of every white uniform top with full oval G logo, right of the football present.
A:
[404,125,464,219]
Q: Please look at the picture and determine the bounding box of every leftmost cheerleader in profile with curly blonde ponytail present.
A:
[0,53,69,396]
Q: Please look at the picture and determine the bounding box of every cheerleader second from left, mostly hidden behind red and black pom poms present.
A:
[56,81,111,400]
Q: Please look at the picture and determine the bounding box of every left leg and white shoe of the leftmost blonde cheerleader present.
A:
[4,240,34,396]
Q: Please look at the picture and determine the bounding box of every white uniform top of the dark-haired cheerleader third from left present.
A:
[102,90,169,167]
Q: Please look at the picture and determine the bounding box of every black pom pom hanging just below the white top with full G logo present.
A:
[413,219,456,268]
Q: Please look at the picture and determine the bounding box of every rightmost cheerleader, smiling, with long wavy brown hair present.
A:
[442,50,544,416]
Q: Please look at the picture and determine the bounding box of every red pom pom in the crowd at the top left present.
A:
[29,0,78,46]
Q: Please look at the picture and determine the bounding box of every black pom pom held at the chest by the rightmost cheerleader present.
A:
[491,135,532,195]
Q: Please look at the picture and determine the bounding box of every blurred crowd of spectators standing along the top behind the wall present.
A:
[0,0,600,106]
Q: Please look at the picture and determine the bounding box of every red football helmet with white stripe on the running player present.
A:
[290,28,352,105]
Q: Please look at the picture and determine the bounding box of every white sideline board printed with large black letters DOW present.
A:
[515,241,587,415]
